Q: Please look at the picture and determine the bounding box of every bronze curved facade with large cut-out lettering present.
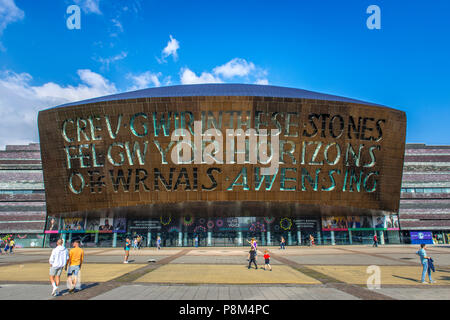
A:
[38,85,406,217]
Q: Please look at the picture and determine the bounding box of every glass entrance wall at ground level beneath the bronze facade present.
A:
[41,216,400,248]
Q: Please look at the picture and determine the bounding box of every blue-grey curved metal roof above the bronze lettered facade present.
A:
[51,83,380,107]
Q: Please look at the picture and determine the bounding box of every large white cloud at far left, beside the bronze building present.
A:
[0,69,117,148]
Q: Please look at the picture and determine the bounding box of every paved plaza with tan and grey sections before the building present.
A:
[0,245,450,300]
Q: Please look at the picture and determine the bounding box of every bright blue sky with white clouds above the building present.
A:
[0,0,450,147]
